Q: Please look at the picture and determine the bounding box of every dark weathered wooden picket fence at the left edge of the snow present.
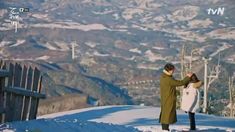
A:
[0,61,45,123]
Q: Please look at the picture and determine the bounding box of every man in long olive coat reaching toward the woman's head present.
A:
[159,63,192,131]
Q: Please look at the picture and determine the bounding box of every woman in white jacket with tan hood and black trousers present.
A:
[181,74,202,130]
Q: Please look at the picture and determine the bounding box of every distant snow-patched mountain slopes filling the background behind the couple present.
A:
[0,0,235,115]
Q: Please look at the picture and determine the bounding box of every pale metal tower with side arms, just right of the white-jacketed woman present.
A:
[203,54,220,113]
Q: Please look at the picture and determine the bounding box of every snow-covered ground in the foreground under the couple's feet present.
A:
[0,106,235,132]
